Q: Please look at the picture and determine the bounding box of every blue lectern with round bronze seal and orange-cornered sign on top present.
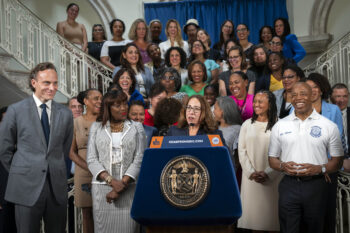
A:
[131,135,242,232]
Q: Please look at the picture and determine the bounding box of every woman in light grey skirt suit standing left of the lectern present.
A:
[87,90,146,233]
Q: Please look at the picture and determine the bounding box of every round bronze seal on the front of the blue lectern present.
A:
[160,155,210,209]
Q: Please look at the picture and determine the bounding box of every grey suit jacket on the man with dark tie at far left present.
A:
[0,96,73,206]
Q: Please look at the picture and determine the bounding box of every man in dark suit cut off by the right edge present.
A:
[331,83,350,172]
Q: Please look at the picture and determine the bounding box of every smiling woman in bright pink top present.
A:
[229,71,254,121]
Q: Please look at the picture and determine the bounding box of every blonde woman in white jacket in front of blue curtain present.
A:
[159,19,190,59]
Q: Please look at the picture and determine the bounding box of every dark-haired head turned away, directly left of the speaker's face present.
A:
[154,98,182,136]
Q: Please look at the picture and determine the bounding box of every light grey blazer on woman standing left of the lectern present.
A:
[87,120,146,184]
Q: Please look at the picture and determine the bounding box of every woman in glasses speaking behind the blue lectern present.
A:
[168,95,225,141]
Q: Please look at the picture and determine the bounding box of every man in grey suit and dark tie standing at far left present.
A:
[0,62,73,233]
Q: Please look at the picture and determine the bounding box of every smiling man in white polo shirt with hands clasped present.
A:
[269,82,344,233]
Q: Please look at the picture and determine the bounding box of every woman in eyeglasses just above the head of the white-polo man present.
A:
[273,64,305,119]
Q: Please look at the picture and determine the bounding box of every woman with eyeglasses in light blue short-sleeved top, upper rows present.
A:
[189,40,220,84]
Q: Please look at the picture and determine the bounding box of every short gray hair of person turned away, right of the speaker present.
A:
[216,96,242,125]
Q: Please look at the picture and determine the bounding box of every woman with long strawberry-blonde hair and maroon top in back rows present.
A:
[129,19,151,64]
